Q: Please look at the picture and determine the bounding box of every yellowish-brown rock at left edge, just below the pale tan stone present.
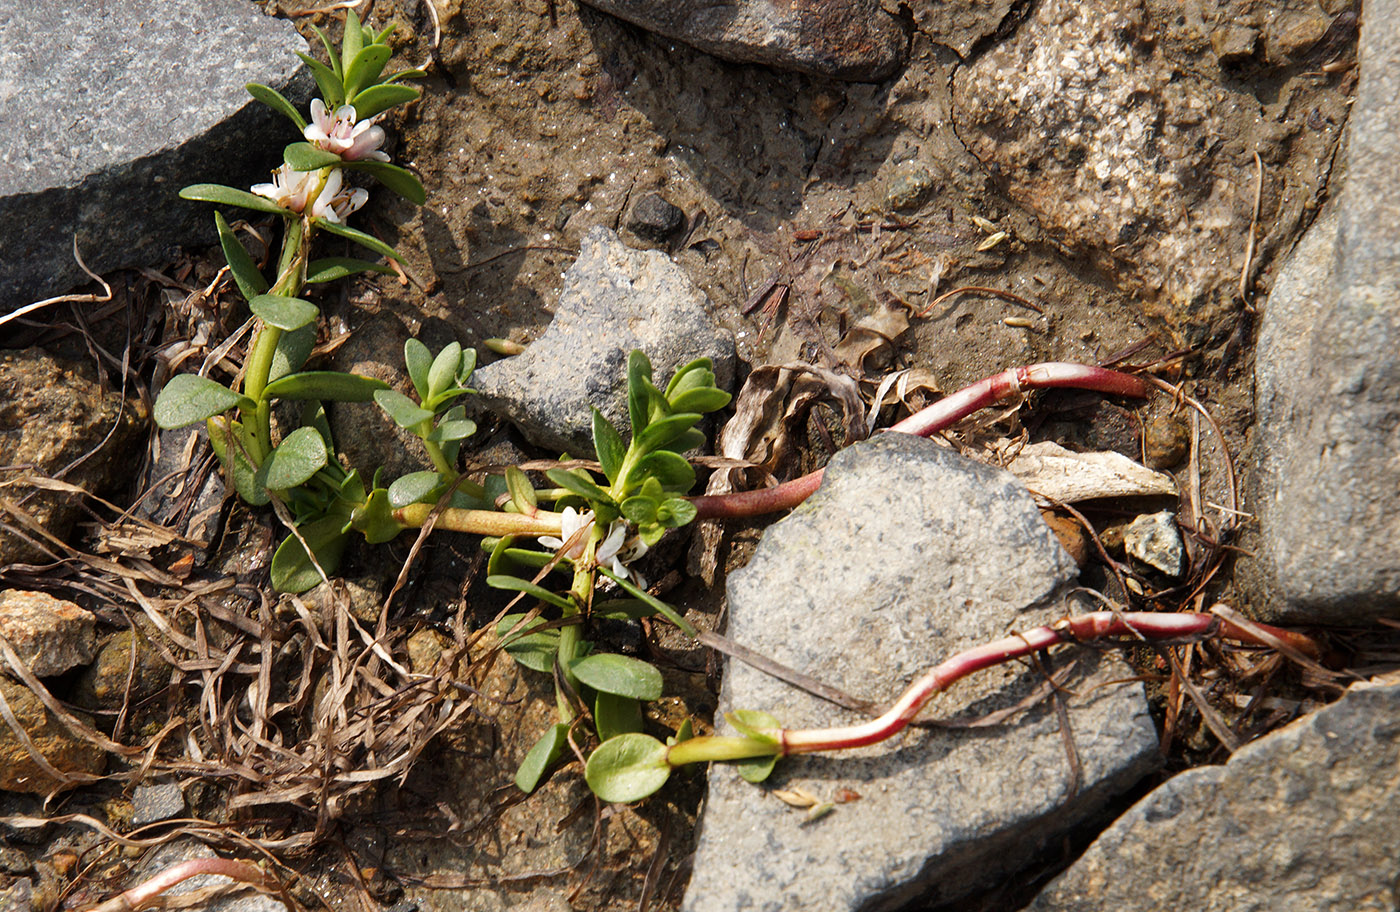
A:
[0,675,106,794]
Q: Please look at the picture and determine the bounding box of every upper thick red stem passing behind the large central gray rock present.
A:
[690,361,1151,520]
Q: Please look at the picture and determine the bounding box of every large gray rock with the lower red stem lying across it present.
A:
[683,434,1158,912]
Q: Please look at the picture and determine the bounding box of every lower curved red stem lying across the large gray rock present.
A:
[777,611,1317,754]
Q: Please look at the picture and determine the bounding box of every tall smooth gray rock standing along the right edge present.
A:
[1254,7,1400,623]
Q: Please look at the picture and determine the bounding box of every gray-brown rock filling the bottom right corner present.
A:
[1030,684,1400,912]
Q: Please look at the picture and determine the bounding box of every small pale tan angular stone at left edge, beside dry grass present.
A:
[0,588,97,678]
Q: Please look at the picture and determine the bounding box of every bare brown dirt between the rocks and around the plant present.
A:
[2,0,1347,911]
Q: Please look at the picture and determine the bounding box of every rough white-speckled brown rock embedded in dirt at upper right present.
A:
[953,0,1345,339]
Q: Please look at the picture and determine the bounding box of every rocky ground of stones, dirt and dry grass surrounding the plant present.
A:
[0,0,1400,912]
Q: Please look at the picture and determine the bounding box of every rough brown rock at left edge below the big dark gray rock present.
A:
[0,349,147,565]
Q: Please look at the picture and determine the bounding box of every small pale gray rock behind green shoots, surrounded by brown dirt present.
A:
[472,227,734,455]
